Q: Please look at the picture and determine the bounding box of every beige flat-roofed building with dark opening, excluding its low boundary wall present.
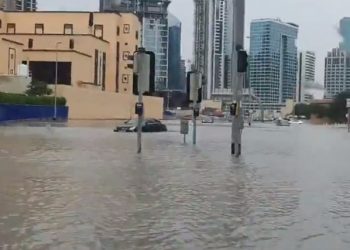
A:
[0,11,162,119]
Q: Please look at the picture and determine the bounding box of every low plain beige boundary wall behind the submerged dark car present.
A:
[57,85,163,120]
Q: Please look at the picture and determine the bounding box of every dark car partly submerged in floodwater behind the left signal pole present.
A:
[114,119,168,133]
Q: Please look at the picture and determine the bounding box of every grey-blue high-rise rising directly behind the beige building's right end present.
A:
[100,0,170,91]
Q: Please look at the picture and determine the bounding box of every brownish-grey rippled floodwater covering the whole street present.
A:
[0,124,350,250]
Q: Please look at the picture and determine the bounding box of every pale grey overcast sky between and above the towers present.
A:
[38,0,350,84]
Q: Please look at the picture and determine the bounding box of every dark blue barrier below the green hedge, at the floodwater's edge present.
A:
[0,104,68,122]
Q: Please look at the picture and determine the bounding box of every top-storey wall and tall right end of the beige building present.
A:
[2,12,140,94]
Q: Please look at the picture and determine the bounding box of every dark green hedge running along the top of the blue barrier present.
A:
[0,92,66,106]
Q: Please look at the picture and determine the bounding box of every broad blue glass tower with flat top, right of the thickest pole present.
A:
[249,19,299,104]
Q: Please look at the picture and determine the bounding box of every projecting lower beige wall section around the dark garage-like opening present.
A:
[0,34,109,90]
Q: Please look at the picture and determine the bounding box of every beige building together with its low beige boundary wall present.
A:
[0,11,163,119]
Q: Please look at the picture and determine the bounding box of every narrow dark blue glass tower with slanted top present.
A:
[168,14,184,90]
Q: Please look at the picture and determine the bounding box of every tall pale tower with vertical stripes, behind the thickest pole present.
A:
[194,0,245,102]
